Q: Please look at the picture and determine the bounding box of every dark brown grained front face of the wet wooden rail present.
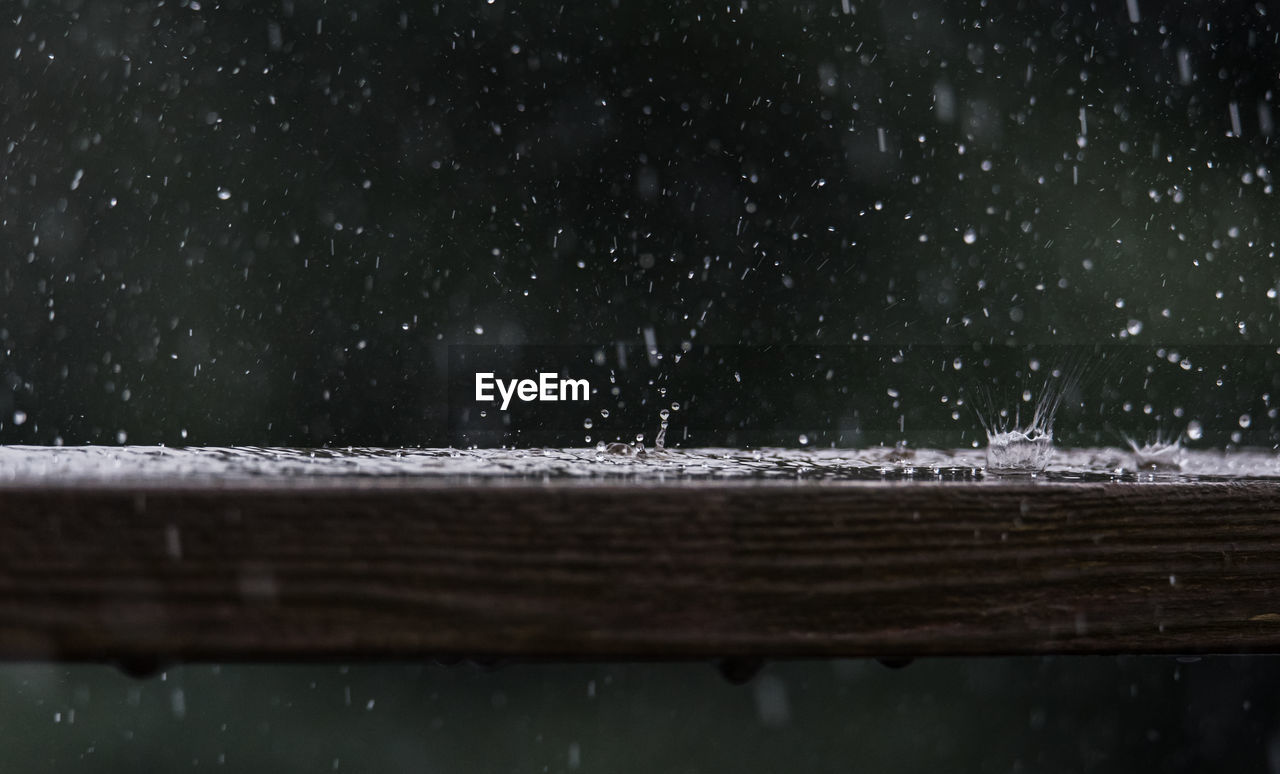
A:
[0,481,1280,660]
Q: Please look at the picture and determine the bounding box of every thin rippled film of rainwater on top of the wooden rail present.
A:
[0,441,1280,485]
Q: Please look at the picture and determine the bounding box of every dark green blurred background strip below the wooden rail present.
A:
[0,656,1280,774]
